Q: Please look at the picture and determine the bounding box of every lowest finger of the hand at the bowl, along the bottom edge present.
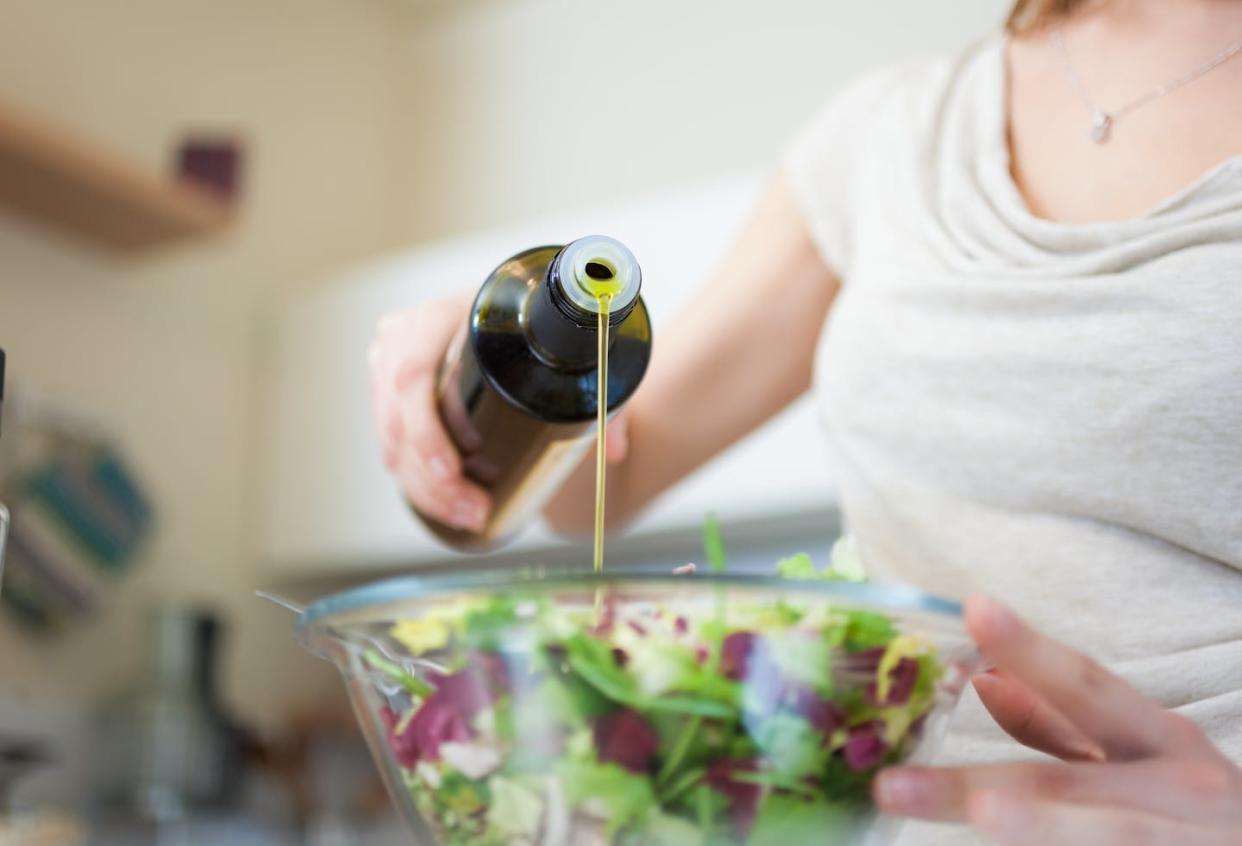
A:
[969,791,1242,846]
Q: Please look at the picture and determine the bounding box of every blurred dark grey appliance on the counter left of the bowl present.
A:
[92,606,245,822]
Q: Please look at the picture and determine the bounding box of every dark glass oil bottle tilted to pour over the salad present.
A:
[420,235,651,546]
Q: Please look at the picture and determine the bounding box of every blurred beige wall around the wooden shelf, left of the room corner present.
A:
[0,0,404,717]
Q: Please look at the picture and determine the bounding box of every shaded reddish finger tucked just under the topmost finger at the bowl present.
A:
[974,672,1104,762]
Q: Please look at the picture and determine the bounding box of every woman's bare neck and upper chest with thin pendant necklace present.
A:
[1009,0,1242,222]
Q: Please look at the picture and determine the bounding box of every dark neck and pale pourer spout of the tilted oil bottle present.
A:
[527,239,638,370]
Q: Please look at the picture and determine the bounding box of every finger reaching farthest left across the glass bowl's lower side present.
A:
[874,759,1242,819]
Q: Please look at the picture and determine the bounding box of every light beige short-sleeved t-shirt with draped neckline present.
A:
[786,39,1242,846]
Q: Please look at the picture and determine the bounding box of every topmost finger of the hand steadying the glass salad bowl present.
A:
[966,595,1186,760]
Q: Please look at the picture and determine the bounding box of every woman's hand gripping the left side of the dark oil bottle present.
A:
[368,297,492,532]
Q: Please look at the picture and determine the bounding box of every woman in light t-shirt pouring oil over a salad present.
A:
[373,0,1242,846]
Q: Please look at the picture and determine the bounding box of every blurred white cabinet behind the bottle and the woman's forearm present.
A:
[261,176,836,578]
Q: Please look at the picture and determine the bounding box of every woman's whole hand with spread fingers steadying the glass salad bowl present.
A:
[874,596,1242,846]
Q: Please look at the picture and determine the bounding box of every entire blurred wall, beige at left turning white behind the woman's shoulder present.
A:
[0,0,1006,721]
